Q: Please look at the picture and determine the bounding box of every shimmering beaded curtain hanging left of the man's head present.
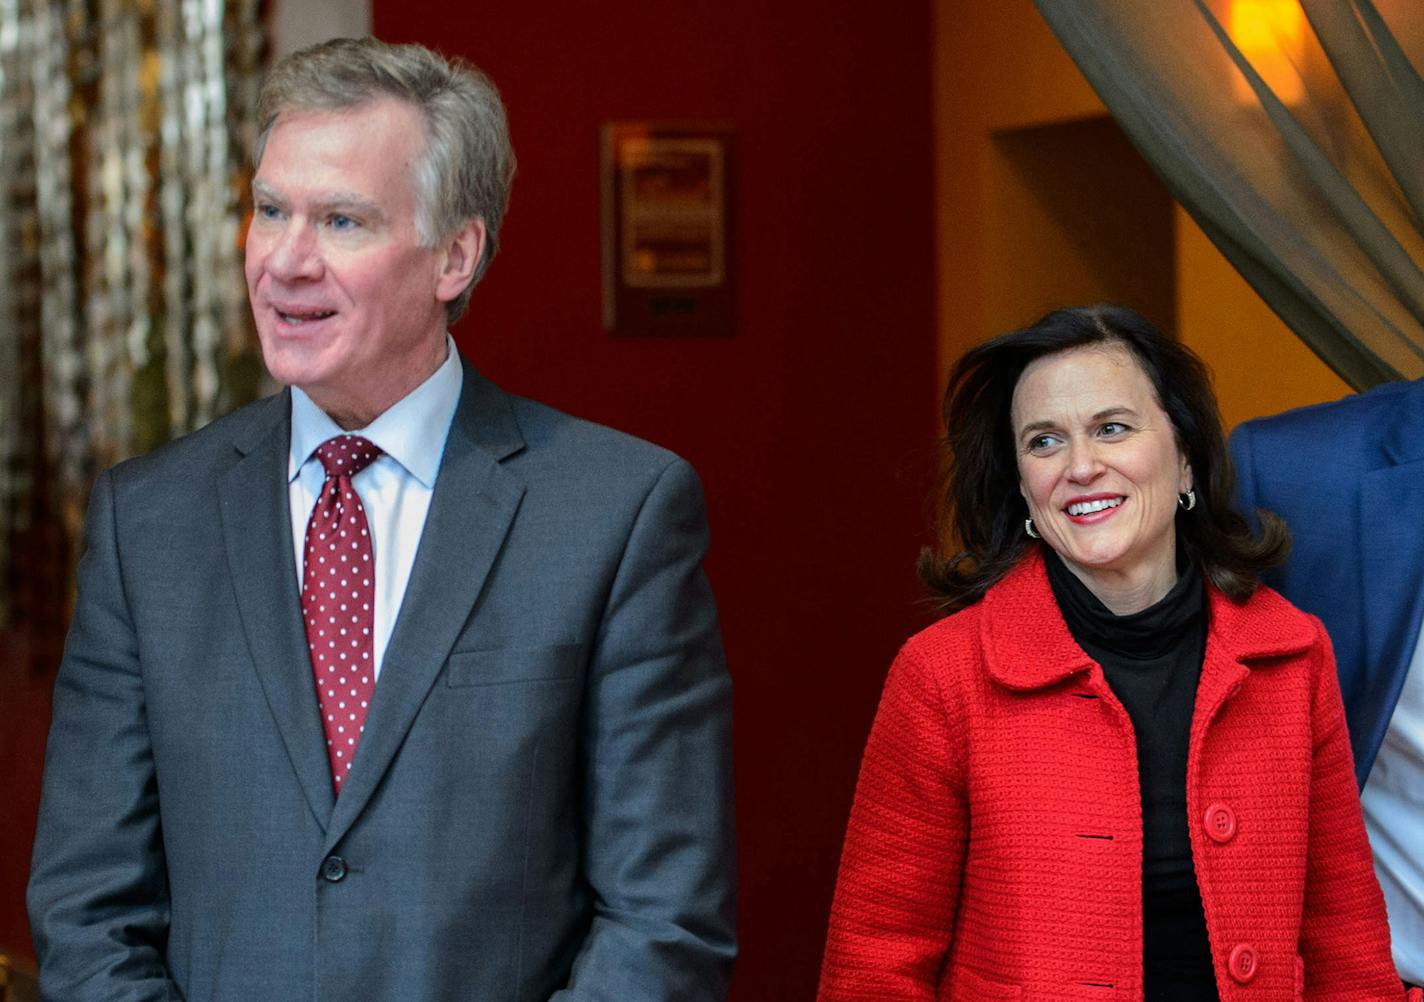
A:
[0,0,263,668]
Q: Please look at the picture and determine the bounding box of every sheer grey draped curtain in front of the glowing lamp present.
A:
[1035,0,1424,389]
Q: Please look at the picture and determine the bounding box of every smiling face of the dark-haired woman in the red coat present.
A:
[1011,344,1192,612]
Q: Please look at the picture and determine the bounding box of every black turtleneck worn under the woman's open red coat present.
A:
[1045,548,1219,1002]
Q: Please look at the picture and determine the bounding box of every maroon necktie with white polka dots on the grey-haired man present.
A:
[302,436,380,794]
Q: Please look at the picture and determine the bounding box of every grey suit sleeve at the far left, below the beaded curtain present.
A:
[28,474,182,1002]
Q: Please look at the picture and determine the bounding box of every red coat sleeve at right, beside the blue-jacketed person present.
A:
[1300,623,1404,1002]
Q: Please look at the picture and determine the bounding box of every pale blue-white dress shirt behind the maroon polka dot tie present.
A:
[288,334,464,679]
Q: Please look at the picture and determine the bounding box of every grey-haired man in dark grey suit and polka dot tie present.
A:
[28,40,735,1002]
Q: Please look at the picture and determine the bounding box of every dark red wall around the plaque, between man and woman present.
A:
[375,0,936,1002]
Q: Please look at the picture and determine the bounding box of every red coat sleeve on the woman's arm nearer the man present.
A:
[817,652,968,1002]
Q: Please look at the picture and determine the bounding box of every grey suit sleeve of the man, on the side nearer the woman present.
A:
[554,460,736,1002]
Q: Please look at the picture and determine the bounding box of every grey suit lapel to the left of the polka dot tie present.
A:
[218,393,333,828]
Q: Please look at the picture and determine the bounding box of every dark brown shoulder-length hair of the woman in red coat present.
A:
[920,306,1290,612]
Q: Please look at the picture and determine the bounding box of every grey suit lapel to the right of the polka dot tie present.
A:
[326,366,524,847]
